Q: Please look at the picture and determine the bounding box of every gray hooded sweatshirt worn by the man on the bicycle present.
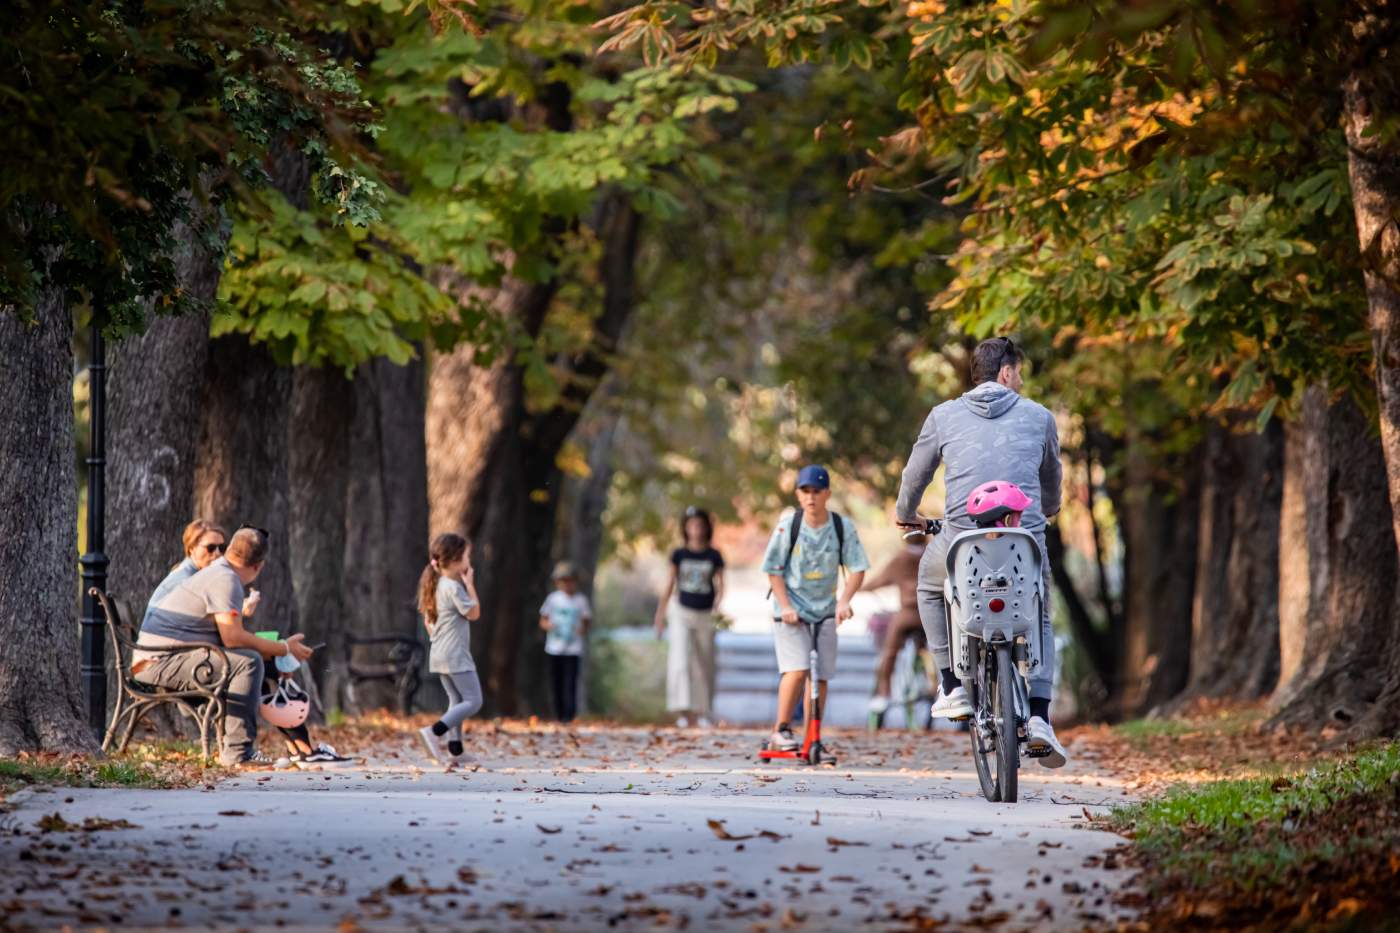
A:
[895,382,1060,534]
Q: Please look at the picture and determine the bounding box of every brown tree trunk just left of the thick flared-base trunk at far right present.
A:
[1180,420,1282,702]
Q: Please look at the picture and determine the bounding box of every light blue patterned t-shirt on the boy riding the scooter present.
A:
[763,511,871,619]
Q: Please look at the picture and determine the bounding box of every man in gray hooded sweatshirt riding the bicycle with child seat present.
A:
[895,338,1065,768]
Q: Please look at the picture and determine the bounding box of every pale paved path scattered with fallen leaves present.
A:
[0,724,1127,932]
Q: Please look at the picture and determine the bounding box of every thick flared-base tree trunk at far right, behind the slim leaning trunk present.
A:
[1274,383,1396,730]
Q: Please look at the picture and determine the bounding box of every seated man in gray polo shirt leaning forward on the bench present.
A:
[132,528,311,766]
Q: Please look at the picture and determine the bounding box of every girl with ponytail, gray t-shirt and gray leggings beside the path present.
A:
[419,534,482,761]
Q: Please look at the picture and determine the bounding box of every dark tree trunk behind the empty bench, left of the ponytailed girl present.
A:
[330,359,428,706]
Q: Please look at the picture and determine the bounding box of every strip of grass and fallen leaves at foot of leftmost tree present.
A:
[0,741,227,800]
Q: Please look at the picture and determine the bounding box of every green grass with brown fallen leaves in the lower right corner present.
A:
[1109,742,1400,926]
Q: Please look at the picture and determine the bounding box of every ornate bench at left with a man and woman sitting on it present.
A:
[88,587,234,761]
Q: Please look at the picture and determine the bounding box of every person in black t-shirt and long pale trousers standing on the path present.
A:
[655,506,724,728]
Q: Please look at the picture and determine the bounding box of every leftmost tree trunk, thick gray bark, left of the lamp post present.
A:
[0,281,98,756]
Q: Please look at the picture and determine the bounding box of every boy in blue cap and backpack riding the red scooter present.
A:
[763,465,869,751]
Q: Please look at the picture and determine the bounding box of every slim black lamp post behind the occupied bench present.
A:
[78,319,108,741]
